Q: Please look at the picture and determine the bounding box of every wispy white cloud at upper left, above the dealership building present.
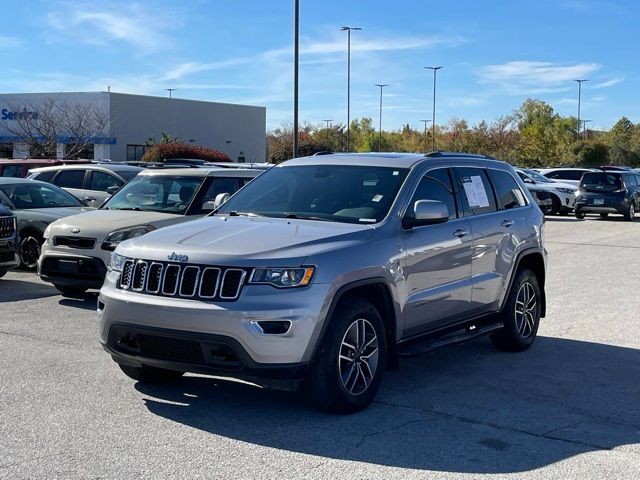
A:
[47,2,181,53]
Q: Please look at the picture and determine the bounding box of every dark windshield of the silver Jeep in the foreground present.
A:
[218,165,407,223]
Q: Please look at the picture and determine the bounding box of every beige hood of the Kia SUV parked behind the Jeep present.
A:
[49,210,188,241]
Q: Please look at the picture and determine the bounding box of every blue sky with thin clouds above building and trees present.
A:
[0,0,640,128]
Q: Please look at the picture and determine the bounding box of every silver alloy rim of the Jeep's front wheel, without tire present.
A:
[338,318,378,395]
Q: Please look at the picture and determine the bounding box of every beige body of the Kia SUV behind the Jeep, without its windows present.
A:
[38,168,261,288]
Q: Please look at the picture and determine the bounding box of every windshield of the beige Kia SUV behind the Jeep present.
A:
[101,175,204,215]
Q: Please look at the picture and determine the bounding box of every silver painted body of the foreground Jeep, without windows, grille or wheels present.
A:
[98,154,546,385]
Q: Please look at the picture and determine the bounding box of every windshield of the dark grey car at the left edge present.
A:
[0,182,82,210]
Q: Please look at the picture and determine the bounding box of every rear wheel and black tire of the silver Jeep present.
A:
[490,268,542,352]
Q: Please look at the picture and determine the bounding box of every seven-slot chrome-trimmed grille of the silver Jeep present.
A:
[118,260,247,301]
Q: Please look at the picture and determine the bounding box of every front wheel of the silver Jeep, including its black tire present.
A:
[305,298,387,413]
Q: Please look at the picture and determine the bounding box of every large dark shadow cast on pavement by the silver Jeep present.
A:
[136,337,640,473]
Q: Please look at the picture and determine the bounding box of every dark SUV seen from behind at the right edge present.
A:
[575,170,640,221]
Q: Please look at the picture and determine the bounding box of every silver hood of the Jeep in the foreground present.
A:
[116,216,375,266]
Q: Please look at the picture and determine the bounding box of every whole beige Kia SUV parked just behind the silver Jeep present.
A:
[38,168,262,296]
